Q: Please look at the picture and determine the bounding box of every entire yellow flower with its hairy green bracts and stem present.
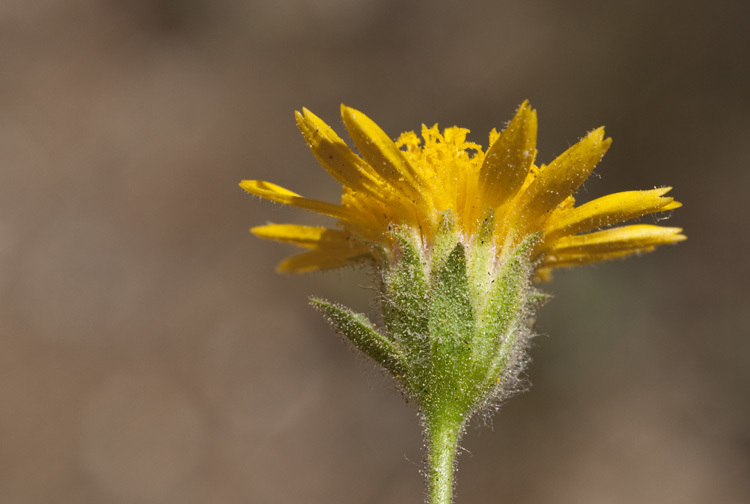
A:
[245,102,685,503]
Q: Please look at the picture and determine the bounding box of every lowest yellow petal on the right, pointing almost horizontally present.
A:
[550,224,686,256]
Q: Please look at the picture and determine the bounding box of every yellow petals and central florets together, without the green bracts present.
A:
[240,101,685,278]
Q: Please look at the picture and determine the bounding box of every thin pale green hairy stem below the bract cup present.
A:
[427,415,463,504]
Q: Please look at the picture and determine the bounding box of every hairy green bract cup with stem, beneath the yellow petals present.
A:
[313,212,540,499]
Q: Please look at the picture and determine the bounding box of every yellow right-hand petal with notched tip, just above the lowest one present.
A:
[546,187,680,240]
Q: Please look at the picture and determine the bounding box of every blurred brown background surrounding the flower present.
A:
[0,0,750,504]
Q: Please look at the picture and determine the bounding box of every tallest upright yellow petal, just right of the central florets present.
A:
[479,100,537,208]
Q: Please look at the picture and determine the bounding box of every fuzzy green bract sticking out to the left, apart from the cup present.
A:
[310,298,407,378]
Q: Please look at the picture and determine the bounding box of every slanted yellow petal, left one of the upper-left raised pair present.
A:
[294,108,383,198]
